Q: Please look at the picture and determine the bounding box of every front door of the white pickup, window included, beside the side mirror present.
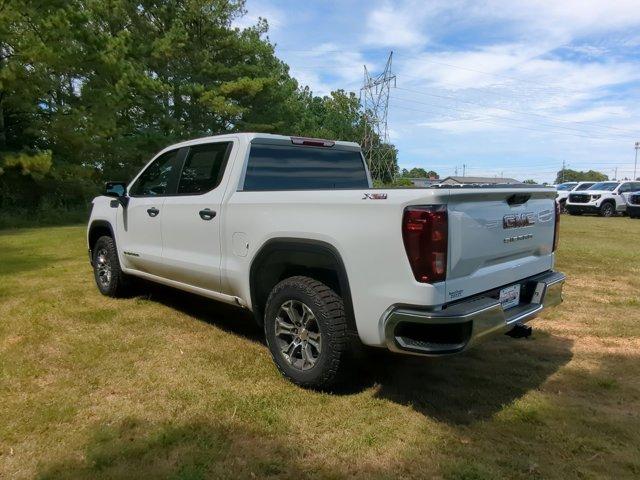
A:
[116,149,181,275]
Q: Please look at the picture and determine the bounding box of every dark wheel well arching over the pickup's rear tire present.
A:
[249,239,356,332]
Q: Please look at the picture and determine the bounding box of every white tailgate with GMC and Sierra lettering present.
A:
[446,187,556,301]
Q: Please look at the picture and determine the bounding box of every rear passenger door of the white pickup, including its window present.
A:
[162,140,237,291]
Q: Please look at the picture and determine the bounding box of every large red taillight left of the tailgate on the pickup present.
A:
[402,205,448,283]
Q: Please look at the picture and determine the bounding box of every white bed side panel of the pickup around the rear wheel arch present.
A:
[222,190,449,345]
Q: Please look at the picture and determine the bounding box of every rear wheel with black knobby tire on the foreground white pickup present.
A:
[264,276,349,390]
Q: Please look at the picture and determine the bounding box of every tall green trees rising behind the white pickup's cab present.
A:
[0,0,397,218]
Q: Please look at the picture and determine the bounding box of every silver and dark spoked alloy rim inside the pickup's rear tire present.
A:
[275,300,322,371]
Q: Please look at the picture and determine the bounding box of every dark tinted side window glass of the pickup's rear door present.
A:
[178,142,231,195]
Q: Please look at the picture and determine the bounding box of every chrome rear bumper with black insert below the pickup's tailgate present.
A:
[383,271,565,356]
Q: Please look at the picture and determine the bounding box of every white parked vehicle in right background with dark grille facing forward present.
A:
[565,181,640,217]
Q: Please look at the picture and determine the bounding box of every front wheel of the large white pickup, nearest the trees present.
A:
[92,235,131,298]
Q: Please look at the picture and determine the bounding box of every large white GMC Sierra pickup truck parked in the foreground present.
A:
[87,133,565,388]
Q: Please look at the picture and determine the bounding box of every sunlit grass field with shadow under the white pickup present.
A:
[0,217,640,479]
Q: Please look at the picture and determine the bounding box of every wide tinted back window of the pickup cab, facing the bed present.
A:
[244,145,369,191]
